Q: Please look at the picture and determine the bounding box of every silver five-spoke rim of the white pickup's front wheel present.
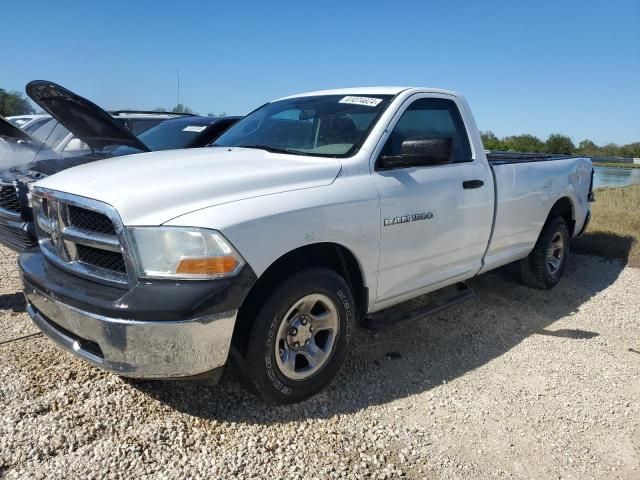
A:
[275,293,340,380]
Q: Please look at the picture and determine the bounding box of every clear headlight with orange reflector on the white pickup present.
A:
[129,227,244,280]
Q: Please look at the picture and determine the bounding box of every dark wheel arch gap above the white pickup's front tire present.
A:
[232,242,369,354]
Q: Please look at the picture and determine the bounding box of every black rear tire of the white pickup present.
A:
[520,217,571,290]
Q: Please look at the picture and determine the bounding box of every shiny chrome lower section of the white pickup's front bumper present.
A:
[25,286,237,378]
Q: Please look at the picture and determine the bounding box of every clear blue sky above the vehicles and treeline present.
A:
[0,0,640,144]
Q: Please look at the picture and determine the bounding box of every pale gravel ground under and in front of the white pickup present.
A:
[0,244,640,479]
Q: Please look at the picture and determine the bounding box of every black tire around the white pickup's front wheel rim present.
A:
[235,268,355,405]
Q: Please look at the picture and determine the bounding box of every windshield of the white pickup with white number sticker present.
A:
[213,95,391,157]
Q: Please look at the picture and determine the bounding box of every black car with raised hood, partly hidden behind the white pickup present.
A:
[0,80,240,252]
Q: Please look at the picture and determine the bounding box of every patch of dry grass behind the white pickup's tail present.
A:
[572,185,640,267]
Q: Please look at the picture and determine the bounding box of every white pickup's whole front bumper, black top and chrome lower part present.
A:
[19,250,255,379]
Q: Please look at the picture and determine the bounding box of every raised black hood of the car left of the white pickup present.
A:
[26,80,149,152]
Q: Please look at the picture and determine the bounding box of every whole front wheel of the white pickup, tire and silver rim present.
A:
[239,268,355,404]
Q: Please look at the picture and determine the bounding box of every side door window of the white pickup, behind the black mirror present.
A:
[380,98,472,163]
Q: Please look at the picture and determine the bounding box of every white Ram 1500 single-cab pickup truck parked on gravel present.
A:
[20,87,593,403]
